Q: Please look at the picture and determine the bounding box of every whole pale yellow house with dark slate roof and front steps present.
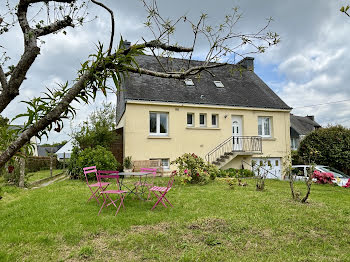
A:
[117,55,291,177]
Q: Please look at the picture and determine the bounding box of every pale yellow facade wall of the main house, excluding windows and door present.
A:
[118,101,290,172]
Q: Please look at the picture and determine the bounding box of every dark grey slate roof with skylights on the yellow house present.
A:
[120,55,291,110]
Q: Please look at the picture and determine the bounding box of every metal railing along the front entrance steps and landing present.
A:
[205,136,262,163]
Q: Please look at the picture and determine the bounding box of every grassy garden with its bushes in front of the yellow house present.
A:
[0,105,350,261]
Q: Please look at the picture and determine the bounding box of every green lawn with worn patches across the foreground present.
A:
[0,179,350,261]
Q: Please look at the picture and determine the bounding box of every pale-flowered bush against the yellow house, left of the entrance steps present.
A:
[171,153,219,184]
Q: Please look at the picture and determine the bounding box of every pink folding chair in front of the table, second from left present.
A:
[97,170,128,216]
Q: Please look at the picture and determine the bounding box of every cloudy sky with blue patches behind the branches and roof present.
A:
[0,0,350,143]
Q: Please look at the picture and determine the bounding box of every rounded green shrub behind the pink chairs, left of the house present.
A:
[68,146,122,180]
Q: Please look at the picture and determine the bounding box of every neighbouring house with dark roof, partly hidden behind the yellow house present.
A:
[290,114,321,150]
